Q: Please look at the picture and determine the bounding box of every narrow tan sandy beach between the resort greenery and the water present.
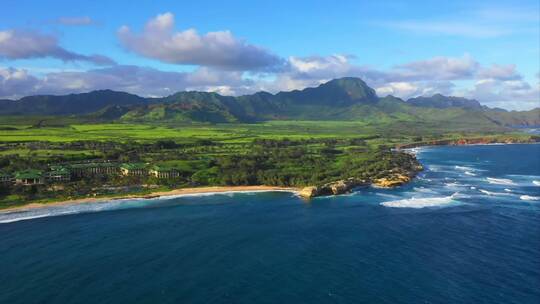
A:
[0,185,299,214]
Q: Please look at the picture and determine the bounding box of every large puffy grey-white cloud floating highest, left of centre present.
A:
[118,13,282,70]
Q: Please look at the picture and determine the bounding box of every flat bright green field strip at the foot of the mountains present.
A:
[0,117,516,142]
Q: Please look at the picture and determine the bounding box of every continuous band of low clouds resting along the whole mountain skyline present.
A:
[0,55,540,109]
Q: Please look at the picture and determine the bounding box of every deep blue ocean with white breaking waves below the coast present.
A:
[0,145,540,304]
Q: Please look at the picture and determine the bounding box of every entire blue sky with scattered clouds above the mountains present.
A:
[0,0,540,110]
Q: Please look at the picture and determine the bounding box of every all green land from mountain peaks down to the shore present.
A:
[0,78,540,208]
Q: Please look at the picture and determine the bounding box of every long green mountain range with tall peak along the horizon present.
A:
[0,77,540,130]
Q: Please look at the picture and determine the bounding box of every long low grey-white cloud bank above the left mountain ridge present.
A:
[0,65,253,98]
